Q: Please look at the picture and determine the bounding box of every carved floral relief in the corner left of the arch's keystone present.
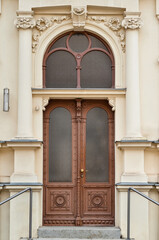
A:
[32,16,70,52]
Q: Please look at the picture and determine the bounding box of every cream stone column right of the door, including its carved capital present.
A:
[122,12,142,140]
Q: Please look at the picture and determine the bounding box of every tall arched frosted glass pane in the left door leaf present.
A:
[49,107,72,182]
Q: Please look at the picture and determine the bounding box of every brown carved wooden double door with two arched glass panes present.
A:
[43,99,114,226]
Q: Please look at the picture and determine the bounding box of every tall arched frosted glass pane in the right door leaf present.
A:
[86,108,109,182]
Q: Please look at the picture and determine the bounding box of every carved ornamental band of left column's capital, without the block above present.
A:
[14,17,35,30]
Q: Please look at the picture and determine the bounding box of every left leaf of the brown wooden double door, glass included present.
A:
[43,101,77,225]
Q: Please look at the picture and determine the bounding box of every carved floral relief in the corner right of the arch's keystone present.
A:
[88,16,125,52]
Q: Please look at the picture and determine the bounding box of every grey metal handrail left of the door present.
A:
[0,188,33,240]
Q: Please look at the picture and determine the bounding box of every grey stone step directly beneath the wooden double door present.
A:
[38,226,120,239]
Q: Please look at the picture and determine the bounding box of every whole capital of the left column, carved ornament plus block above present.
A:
[14,11,36,30]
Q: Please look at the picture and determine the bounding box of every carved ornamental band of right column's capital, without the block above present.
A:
[122,17,143,30]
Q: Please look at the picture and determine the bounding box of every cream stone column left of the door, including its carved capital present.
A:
[15,11,35,138]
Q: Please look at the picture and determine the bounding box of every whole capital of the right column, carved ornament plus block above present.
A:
[122,12,143,30]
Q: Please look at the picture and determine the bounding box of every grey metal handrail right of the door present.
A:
[126,187,159,240]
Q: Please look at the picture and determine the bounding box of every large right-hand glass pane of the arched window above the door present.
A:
[81,51,112,88]
